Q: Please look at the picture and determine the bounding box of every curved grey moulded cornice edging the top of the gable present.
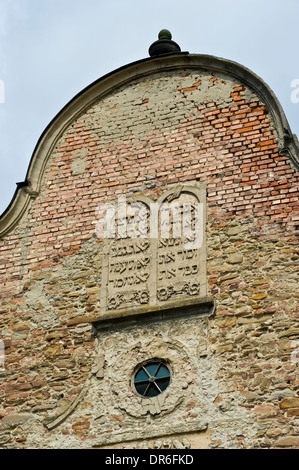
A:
[0,53,299,236]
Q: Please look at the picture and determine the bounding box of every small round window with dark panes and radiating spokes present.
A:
[134,361,170,398]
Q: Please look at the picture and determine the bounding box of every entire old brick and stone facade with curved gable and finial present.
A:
[0,32,299,449]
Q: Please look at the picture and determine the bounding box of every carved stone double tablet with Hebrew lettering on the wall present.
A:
[98,185,206,315]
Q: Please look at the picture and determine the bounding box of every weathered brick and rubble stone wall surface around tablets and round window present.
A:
[0,57,299,448]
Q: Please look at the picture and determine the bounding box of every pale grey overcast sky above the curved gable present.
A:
[0,0,299,214]
